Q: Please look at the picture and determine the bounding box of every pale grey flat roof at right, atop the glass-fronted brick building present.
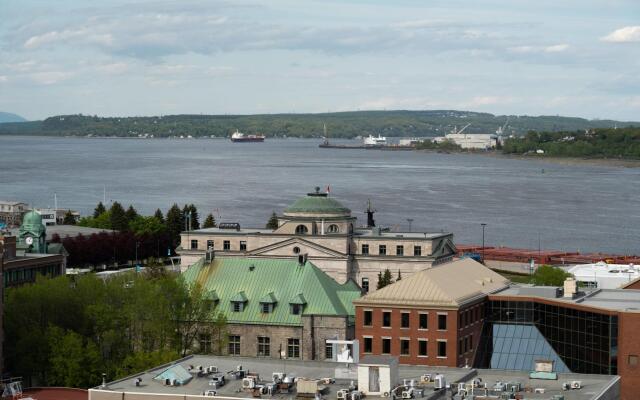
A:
[492,285,640,312]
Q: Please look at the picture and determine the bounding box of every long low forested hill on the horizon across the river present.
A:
[0,110,640,138]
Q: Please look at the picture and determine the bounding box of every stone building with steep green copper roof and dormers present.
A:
[183,257,361,360]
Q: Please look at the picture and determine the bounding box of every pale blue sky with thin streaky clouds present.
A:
[0,0,640,121]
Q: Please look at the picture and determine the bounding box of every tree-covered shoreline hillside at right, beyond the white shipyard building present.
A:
[502,127,640,159]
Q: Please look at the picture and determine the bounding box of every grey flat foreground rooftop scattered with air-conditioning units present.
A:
[99,355,618,400]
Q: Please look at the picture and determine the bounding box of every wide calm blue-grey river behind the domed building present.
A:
[0,136,640,254]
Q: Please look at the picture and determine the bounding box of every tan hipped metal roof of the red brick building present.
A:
[356,258,509,307]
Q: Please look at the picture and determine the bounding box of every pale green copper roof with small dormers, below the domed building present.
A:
[183,258,360,326]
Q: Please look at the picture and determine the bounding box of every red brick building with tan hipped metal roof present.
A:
[354,259,509,367]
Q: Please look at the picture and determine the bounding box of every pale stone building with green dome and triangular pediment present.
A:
[177,188,456,292]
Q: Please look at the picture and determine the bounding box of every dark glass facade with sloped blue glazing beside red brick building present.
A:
[475,296,618,375]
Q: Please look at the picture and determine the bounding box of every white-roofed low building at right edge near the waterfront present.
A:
[567,261,640,289]
